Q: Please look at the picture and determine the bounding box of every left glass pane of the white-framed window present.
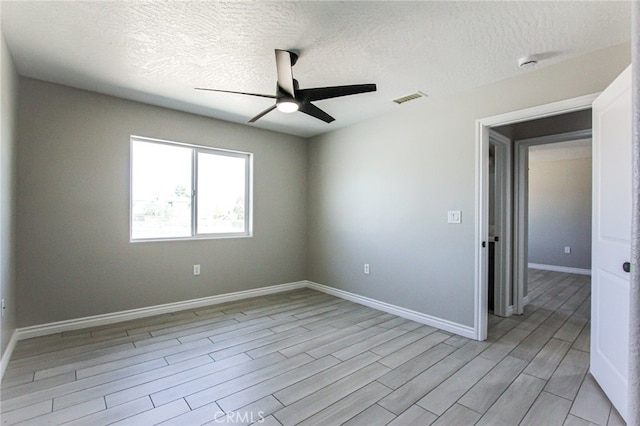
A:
[131,141,192,239]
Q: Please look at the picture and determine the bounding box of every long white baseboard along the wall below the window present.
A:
[16,281,306,340]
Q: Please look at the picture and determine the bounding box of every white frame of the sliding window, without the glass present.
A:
[129,135,253,243]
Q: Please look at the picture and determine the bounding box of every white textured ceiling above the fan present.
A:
[1,0,631,137]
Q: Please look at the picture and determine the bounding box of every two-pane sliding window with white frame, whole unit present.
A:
[131,137,251,241]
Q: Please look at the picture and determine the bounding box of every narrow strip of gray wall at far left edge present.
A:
[0,35,18,354]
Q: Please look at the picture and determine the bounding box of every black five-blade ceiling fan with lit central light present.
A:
[196,49,376,123]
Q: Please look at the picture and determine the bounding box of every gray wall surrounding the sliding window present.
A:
[16,78,307,327]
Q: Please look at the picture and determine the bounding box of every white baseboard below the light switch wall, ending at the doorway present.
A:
[307,281,476,340]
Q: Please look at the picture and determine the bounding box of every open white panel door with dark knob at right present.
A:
[591,66,632,419]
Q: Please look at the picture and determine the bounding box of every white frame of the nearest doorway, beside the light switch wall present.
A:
[474,93,598,340]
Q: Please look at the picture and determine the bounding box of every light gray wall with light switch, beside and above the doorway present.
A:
[309,44,630,327]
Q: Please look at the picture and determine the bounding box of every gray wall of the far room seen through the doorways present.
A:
[529,158,591,269]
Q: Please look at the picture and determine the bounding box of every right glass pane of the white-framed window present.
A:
[197,152,247,234]
